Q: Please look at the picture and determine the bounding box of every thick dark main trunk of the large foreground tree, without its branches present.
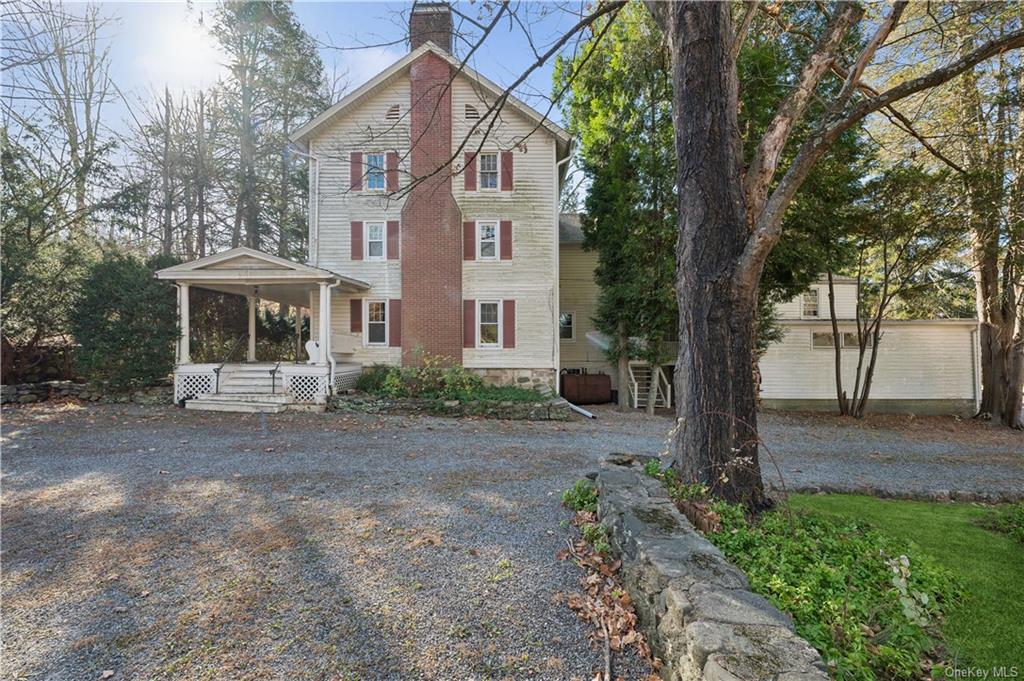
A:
[648,2,765,508]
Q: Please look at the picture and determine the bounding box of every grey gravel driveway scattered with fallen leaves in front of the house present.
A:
[0,405,1024,679]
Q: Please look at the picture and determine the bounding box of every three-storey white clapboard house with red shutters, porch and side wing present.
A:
[157,3,974,412]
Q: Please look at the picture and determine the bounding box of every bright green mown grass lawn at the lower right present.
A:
[792,495,1024,669]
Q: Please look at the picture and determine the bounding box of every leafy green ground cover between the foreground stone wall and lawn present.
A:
[708,503,961,681]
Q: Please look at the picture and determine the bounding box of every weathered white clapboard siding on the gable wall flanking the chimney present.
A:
[309,66,559,384]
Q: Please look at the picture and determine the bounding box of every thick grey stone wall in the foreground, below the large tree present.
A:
[597,456,828,681]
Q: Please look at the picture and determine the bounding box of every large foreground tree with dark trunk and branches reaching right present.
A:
[647,2,1024,507]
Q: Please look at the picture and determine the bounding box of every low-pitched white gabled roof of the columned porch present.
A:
[156,246,370,307]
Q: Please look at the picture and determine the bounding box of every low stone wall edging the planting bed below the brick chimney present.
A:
[328,393,571,421]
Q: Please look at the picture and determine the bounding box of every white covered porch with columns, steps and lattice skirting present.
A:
[156,247,370,403]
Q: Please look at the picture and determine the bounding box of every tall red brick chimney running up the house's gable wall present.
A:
[400,3,463,365]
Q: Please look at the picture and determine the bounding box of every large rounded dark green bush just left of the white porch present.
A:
[71,251,178,389]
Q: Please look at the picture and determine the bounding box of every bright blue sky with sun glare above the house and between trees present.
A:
[101,1,593,133]
